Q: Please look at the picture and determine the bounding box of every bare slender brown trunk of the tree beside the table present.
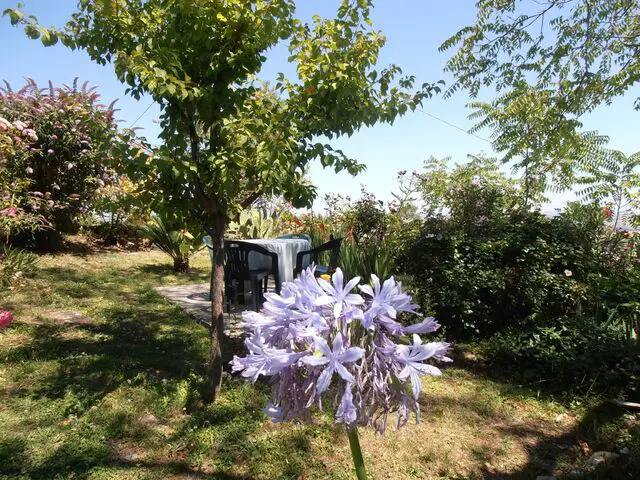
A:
[208,218,225,402]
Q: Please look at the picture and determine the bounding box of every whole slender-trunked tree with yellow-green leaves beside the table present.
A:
[6,0,437,399]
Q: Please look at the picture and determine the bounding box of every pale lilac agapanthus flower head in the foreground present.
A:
[231,267,451,432]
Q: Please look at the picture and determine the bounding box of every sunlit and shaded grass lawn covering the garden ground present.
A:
[0,251,638,480]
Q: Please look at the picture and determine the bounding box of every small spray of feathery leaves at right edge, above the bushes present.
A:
[577,150,640,230]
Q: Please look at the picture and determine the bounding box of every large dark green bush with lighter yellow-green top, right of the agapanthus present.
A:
[400,158,640,339]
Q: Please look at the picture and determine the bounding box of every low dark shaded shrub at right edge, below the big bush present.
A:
[479,317,640,400]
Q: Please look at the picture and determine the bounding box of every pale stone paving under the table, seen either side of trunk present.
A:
[154,283,245,337]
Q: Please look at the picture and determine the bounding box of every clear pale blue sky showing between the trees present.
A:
[0,0,640,210]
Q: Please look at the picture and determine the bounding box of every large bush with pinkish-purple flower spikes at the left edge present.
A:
[0,80,140,244]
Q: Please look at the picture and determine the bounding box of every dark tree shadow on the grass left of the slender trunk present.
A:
[6,306,206,414]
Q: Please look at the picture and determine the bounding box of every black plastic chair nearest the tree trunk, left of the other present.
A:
[224,240,280,311]
